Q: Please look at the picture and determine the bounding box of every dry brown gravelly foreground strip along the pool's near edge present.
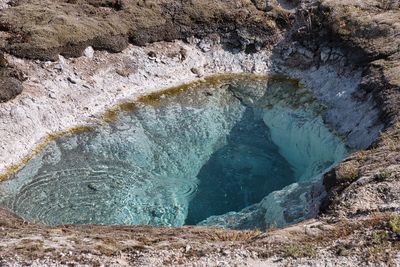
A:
[0,209,400,266]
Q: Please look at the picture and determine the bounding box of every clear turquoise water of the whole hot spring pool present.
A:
[0,76,346,227]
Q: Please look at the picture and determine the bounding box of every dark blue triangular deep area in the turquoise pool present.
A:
[185,108,295,225]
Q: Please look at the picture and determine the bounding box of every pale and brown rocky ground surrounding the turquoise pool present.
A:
[0,0,400,266]
